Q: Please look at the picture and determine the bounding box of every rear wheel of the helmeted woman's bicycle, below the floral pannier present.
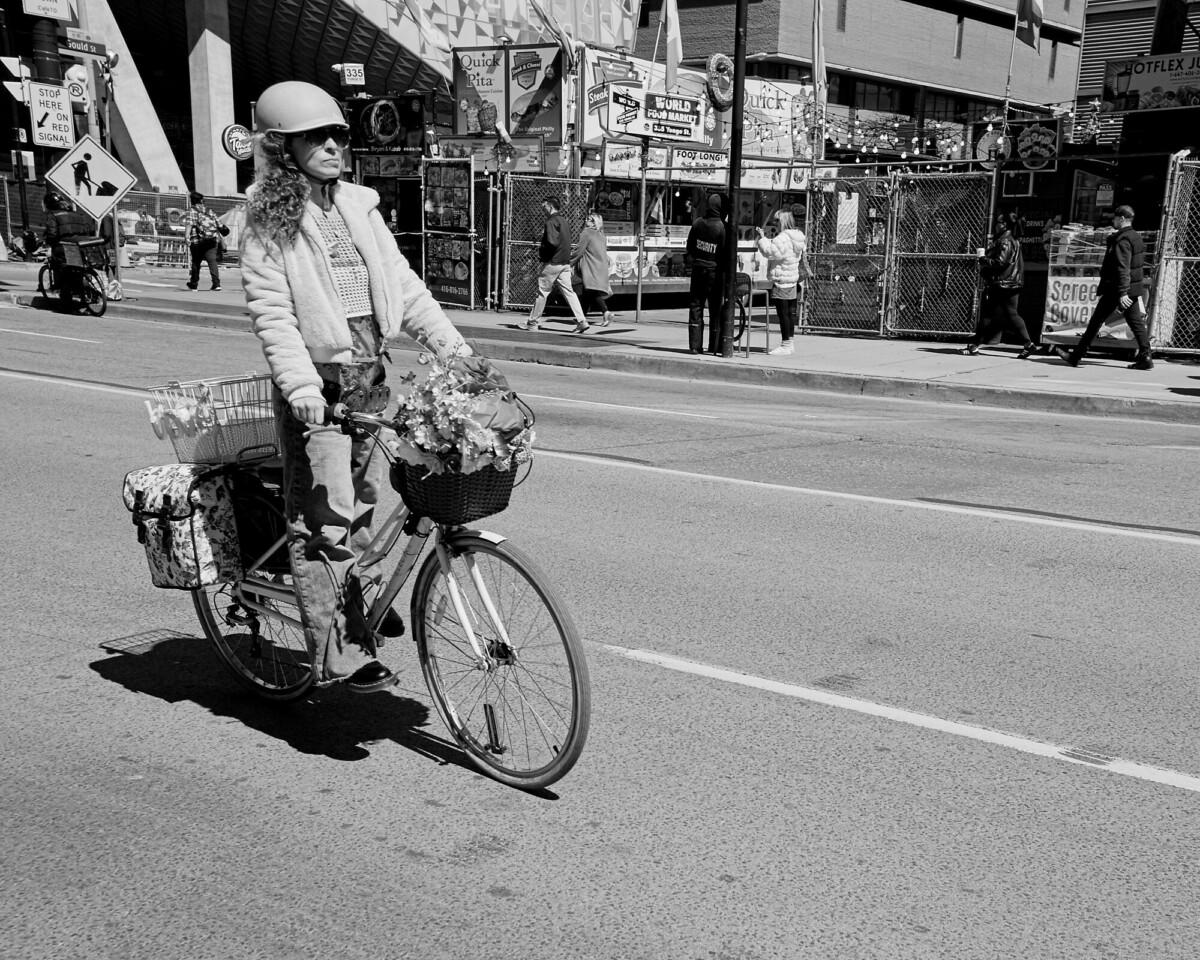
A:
[192,575,314,703]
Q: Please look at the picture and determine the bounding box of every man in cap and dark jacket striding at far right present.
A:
[1054,206,1154,370]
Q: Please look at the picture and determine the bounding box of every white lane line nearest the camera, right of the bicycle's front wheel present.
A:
[601,643,1200,793]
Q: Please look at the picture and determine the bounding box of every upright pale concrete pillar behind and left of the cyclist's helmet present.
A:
[186,0,238,197]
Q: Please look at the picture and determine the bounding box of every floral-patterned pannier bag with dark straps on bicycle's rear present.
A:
[122,463,244,590]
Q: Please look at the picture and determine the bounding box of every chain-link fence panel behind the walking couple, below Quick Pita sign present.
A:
[504,174,592,308]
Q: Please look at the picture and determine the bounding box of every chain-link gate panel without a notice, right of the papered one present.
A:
[887,173,992,334]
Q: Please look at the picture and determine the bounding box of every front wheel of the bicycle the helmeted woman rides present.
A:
[412,530,592,790]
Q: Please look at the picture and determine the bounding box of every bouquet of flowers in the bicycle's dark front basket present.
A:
[395,354,534,474]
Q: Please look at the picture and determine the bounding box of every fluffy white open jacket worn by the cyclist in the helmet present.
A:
[241,182,470,403]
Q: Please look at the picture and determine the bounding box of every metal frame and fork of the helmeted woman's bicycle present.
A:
[232,484,509,672]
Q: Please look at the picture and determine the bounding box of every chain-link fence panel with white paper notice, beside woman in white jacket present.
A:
[800,176,892,334]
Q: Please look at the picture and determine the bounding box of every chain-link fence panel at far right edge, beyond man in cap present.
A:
[1151,157,1200,353]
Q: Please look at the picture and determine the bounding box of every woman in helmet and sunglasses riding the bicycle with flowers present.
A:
[241,82,472,692]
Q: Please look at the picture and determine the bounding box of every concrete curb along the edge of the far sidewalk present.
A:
[4,293,1200,425]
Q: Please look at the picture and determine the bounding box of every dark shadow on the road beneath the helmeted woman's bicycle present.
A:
[90,631,474,772]
